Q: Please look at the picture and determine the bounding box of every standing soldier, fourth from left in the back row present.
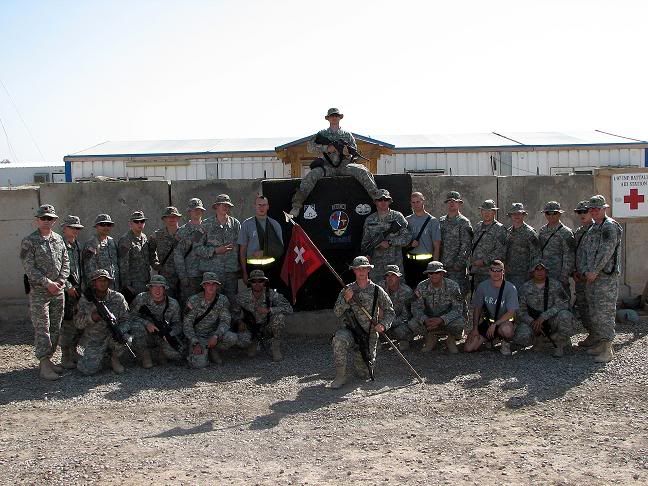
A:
[117,211,159,304]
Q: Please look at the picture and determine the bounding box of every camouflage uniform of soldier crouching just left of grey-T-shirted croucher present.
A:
[410,277,465,340]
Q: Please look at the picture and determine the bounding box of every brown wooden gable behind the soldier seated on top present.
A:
[275,133,395,177]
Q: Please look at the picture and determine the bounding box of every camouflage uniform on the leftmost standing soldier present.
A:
[20,230,70,360]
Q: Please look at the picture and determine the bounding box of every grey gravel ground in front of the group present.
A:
[0,319,648,485]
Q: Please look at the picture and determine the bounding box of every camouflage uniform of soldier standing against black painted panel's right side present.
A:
[361,209,412,281]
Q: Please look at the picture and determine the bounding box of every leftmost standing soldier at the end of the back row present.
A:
[20,204,70,380]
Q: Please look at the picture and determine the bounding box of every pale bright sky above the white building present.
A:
[0,0,648,163]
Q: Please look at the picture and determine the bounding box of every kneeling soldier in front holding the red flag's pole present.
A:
[331,256,395,389]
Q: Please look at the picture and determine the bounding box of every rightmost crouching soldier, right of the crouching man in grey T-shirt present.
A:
[513,260,573,358]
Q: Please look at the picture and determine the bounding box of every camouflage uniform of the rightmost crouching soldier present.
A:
[513,278,574,346]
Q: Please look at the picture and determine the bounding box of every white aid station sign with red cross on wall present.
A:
[612,173,648,218]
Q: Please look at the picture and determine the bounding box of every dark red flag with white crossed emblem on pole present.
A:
[281,224,325,304]
